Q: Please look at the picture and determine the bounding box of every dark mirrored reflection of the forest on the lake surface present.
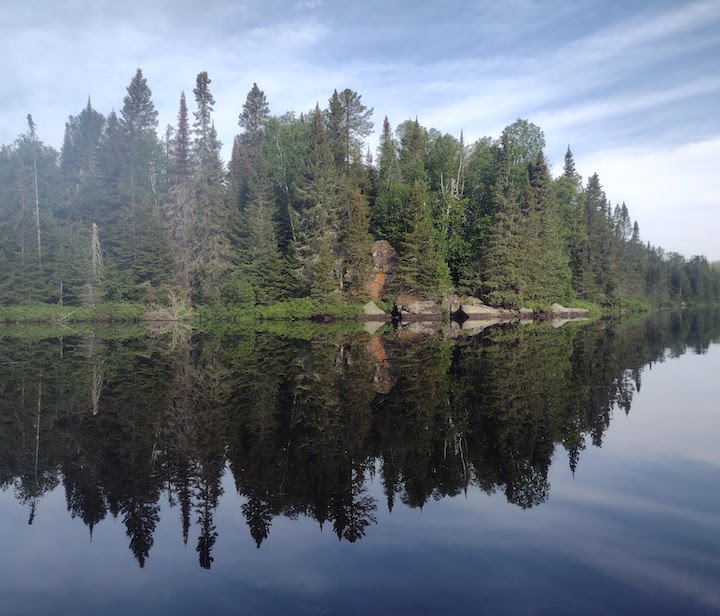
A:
[0,310,720,568]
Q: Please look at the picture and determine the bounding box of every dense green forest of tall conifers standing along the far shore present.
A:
[0,69,720,307]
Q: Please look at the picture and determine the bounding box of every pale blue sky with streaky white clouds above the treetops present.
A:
[0,0,720,261]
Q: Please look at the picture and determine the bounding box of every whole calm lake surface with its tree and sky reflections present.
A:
[0,311,720,614]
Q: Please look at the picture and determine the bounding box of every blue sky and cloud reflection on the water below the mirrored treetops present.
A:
[0,316,720,614]
